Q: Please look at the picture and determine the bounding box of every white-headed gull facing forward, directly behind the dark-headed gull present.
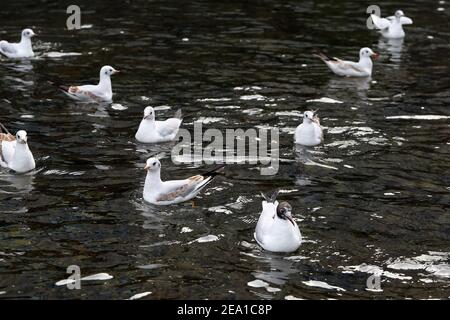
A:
[294,111,323,147]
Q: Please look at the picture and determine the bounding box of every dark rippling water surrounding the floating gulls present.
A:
[0,0,450,299]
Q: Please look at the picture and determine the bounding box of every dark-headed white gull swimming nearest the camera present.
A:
[254,191,302,252]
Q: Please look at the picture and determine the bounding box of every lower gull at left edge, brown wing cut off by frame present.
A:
[0,124,36,173]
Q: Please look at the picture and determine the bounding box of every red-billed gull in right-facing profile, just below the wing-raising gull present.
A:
[315,48,379,77]
